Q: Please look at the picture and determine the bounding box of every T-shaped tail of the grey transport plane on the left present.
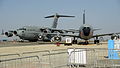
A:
[45,13,75,28]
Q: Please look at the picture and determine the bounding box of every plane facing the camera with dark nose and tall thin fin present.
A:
[47,10,120,44]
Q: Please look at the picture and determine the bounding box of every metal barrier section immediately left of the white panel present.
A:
[42,52,68,68]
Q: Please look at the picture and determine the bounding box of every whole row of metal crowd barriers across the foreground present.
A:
[0,48,120,68]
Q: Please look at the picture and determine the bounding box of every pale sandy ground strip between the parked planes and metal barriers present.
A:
[0,42,107,54]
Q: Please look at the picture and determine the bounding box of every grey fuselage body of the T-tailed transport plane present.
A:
[17,26,54,41]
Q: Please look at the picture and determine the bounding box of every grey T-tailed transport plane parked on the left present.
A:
[5,13,74,42]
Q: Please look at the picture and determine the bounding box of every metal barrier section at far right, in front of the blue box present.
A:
[94,49,120,68]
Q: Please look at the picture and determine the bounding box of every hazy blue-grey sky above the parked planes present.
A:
[0,0,120,33]
